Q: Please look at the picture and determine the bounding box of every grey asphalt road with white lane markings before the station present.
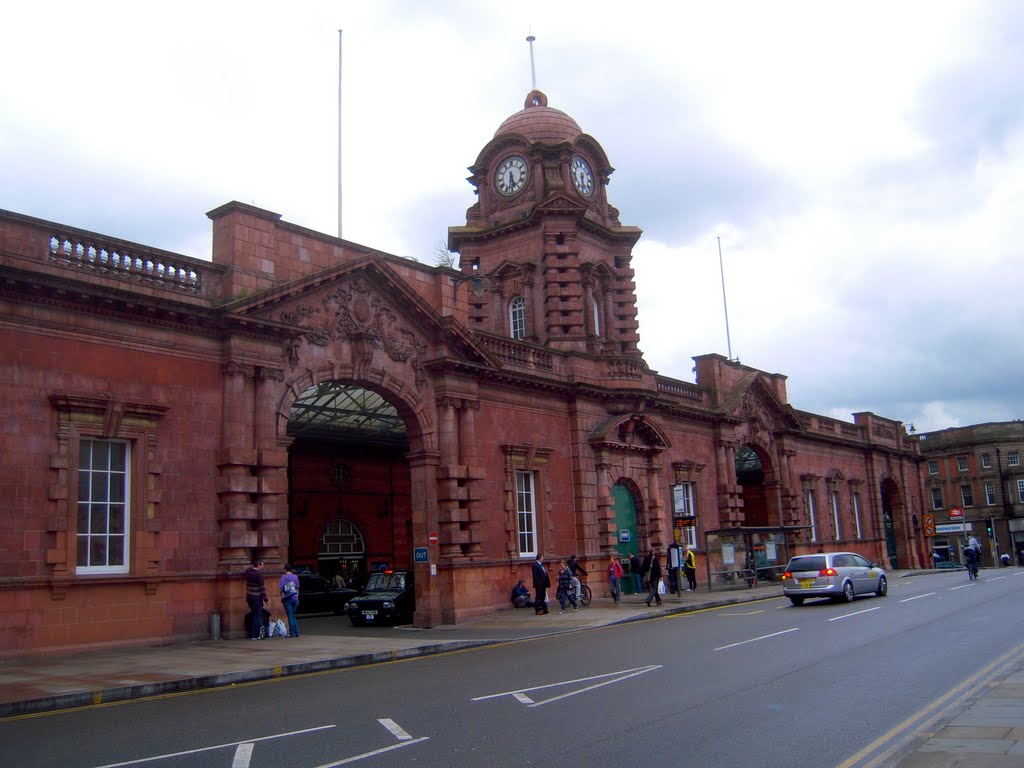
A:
[8,569,1024,768]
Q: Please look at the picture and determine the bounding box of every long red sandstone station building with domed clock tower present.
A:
[0,92,923,654]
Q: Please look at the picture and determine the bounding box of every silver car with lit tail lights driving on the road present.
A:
[782,552,889,605]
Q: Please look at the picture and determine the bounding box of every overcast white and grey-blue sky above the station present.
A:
[0,0,1024,431]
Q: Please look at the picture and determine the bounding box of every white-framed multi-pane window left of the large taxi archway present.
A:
[76,439,130,573]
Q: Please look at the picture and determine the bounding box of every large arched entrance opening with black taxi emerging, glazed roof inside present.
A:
[288,381,413,586]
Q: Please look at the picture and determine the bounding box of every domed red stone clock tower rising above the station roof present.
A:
[449,90,641,358]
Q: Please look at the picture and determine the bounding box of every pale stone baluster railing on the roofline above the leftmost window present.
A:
[49,232,204,294]
